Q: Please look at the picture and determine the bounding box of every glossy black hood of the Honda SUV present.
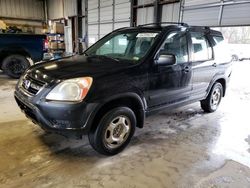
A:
[27,55,132,82]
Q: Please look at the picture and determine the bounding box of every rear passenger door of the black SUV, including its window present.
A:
[190,30,217,98]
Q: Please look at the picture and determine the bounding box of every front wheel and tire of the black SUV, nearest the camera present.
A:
[88,107,136,156]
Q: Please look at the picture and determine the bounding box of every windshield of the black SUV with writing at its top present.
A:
[85,31,159,62]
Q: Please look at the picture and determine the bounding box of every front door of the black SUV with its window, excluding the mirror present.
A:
[148,30,192,108]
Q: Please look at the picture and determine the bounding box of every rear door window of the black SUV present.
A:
[191,32,213,61]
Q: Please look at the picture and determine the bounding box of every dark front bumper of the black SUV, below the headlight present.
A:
[14,87,98,135]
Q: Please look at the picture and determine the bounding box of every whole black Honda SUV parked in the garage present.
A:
[15,23,231,155]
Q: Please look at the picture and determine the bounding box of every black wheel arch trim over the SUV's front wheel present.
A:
[91,93,145,130]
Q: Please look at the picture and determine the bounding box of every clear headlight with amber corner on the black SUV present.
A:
[46,77,93,102]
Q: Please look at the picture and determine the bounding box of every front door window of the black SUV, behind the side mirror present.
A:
[160,31,188,63]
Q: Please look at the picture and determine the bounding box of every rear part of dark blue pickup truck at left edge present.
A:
[0,33,46,78]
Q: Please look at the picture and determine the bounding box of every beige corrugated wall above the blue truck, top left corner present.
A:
[0,0,45,33]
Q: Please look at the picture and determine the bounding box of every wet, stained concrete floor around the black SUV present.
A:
[0,61,250,188]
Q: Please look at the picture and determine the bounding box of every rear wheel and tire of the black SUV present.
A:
[201,82,223,113]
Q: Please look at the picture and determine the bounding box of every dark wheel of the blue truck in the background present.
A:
[2,55,30,78]
